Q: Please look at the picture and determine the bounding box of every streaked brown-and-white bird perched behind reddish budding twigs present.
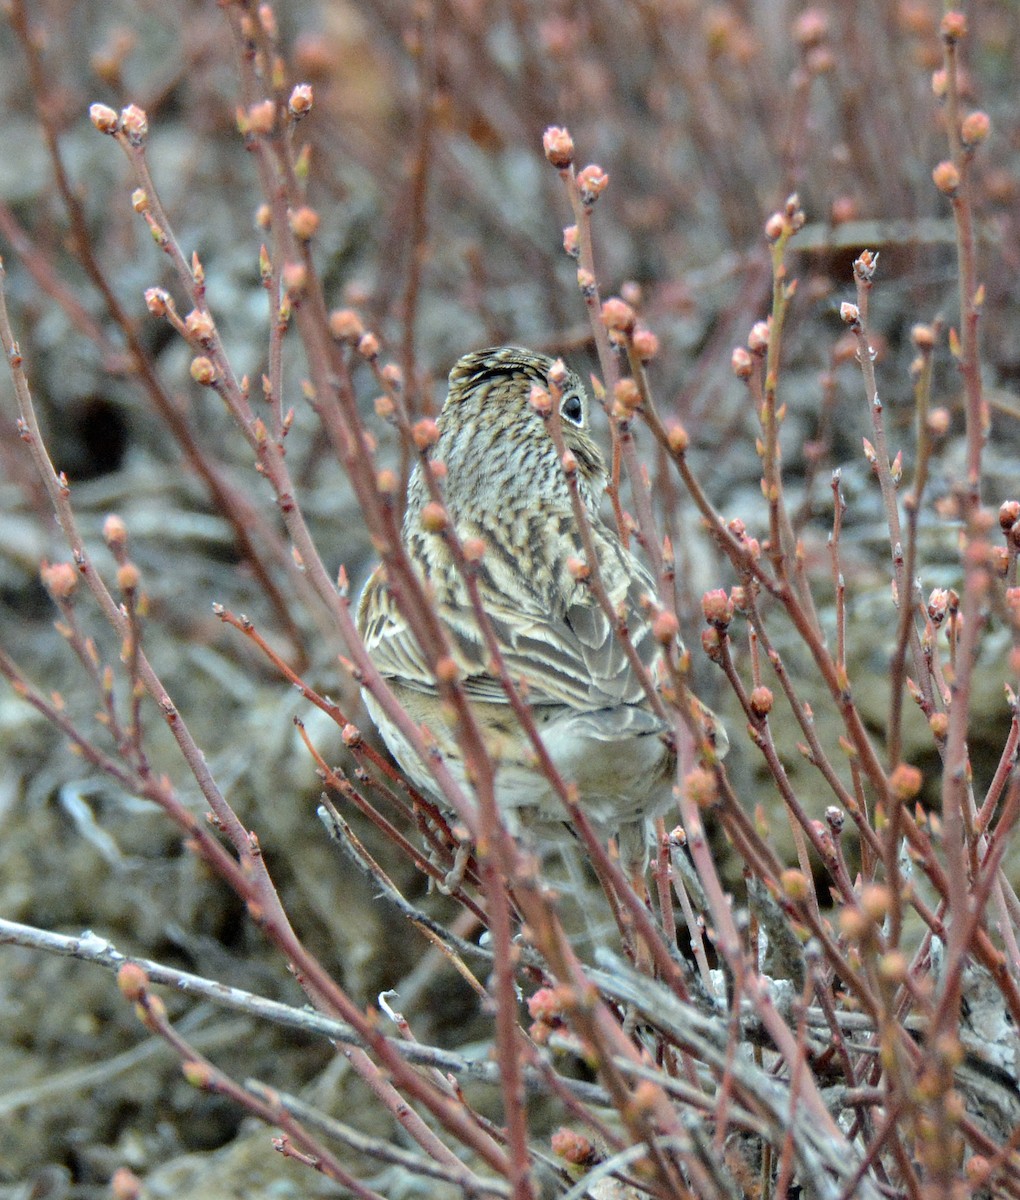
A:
[356,346,726,865]
